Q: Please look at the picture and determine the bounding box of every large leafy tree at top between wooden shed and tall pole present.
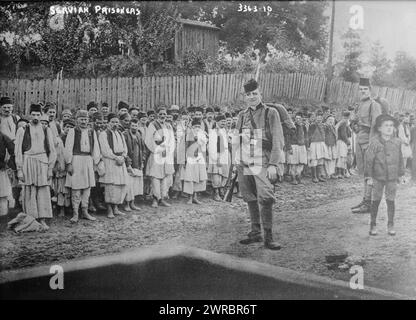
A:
[178,1,327,59]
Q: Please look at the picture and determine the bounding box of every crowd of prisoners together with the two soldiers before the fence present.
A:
[0,79,416,250]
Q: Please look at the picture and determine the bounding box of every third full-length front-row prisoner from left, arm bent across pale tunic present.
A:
[98,113,129,219]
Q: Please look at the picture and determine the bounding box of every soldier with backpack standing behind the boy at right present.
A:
[351,78,382,213]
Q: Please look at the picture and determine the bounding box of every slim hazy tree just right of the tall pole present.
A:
[341,28,362,82]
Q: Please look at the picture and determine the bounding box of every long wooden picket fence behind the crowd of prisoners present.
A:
[0,73,416,112]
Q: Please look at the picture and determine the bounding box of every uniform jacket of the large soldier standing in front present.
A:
[233,103,284,167]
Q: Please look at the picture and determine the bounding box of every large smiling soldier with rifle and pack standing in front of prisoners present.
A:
[233,79,284,250]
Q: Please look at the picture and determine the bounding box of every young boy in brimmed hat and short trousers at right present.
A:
[364,114,404,236]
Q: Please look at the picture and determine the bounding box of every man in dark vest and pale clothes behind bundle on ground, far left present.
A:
[15,104,56,229]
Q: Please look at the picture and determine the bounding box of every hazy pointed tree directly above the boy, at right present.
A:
[369,41,391,86]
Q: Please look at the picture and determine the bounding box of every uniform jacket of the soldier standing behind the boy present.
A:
[355,98,381,144]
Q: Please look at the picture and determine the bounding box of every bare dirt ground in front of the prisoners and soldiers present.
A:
[0,177,416,297]
